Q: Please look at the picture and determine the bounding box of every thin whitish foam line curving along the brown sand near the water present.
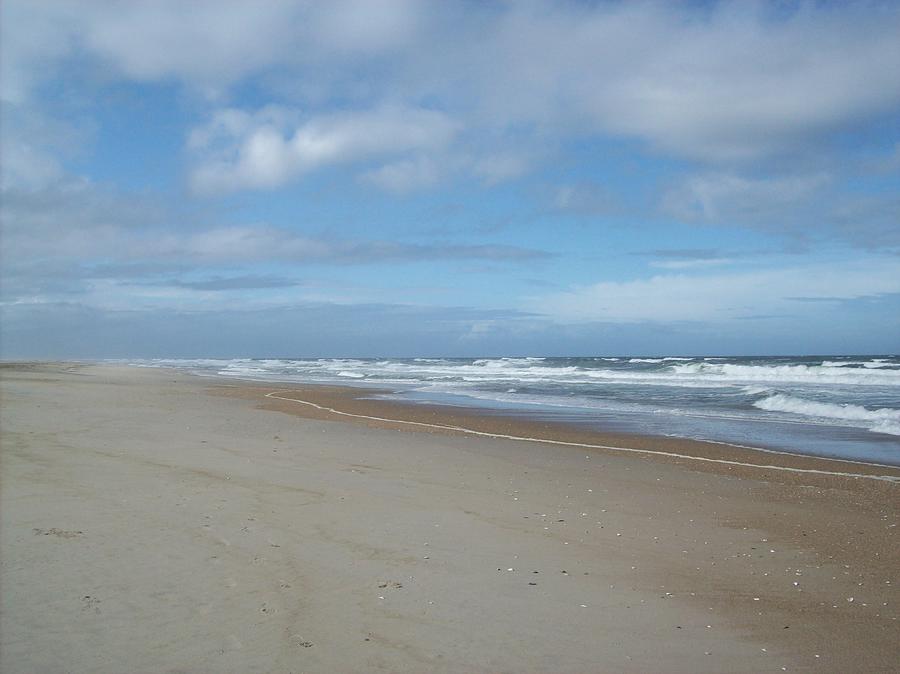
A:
[266,389,900,483]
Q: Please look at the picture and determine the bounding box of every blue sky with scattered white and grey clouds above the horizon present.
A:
[0,0,900,358]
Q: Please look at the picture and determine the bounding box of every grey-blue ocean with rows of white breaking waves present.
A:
[126,355,900,465]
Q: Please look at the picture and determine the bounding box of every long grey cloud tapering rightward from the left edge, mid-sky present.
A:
[0,188,546,276]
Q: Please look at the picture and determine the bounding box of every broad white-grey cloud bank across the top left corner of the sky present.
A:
[0,0,422,101]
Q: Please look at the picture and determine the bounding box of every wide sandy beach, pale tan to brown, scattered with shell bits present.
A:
[0,363,900,673]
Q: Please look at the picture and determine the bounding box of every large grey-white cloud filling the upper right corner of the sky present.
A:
[467,2,900,162]
